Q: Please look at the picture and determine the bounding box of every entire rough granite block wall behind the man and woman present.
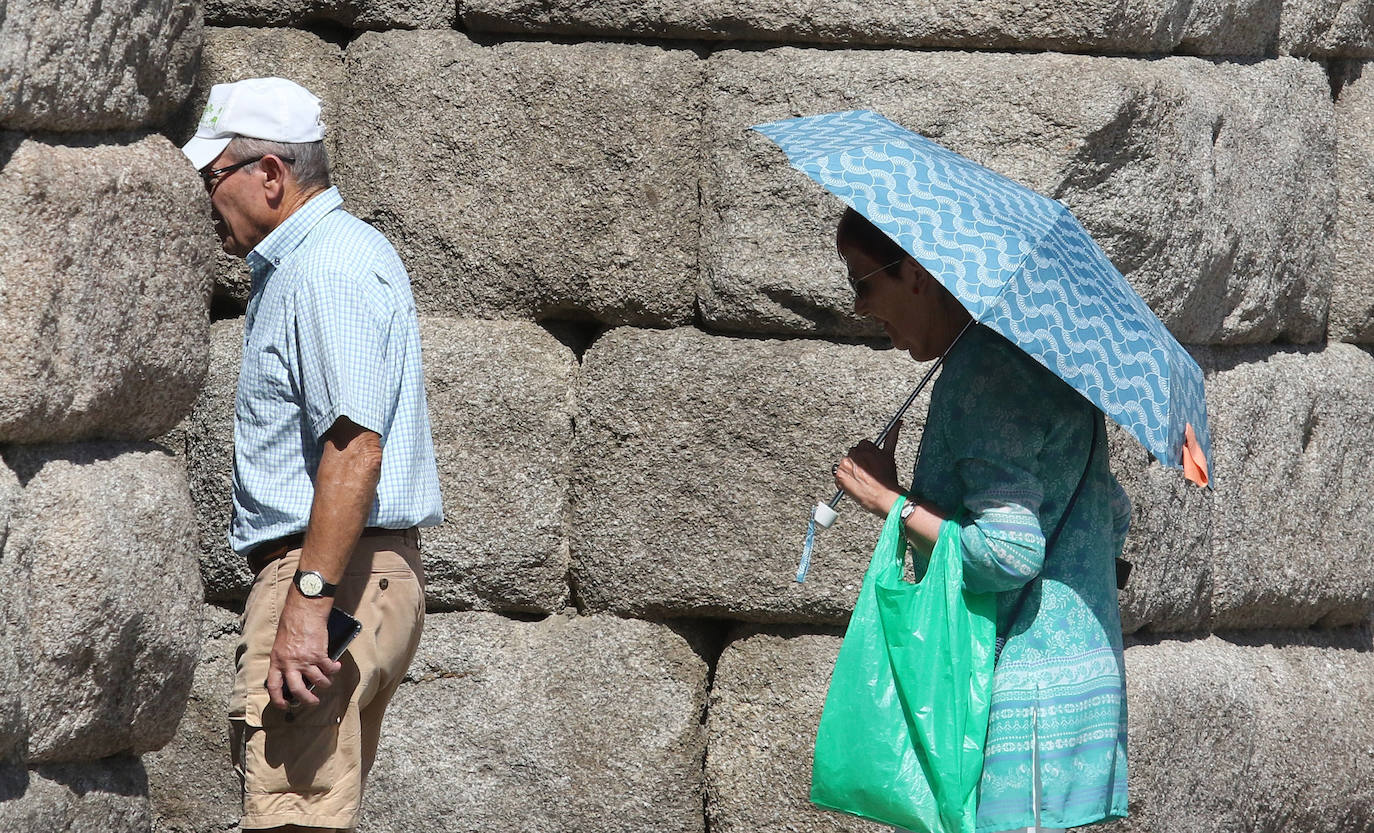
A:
[0,0,1374,833]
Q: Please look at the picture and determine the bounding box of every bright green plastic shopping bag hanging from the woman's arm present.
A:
[811,500,996,833]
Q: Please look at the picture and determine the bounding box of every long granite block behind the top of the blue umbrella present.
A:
[698,47,1334,344]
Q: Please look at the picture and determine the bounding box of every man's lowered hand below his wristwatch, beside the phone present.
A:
[267,587,344,709]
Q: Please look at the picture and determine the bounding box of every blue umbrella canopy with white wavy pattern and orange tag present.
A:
[754,110,1210,485]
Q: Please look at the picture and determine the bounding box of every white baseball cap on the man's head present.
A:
[181,78,324,170]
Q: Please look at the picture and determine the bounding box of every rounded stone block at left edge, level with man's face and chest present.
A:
[0,133,213,443]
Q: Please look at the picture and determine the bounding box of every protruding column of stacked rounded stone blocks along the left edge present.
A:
[0,0,214,833]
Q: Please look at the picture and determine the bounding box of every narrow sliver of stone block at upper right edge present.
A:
[1327,63,1374,344]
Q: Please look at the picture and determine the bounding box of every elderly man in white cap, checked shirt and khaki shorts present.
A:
[183,78,442,830]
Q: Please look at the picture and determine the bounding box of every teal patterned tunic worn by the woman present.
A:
[912,326,1129,833]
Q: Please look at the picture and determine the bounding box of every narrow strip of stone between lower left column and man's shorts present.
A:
[143,605,239,833]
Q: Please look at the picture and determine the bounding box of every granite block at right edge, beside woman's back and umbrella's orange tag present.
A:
[1038,344,1374,634]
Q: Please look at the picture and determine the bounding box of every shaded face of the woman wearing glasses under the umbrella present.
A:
[840,242,952,362]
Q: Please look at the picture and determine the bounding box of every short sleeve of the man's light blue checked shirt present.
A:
[294,274,393,441]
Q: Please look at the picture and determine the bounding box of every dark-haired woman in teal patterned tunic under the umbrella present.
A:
[835,209,1131,833]
